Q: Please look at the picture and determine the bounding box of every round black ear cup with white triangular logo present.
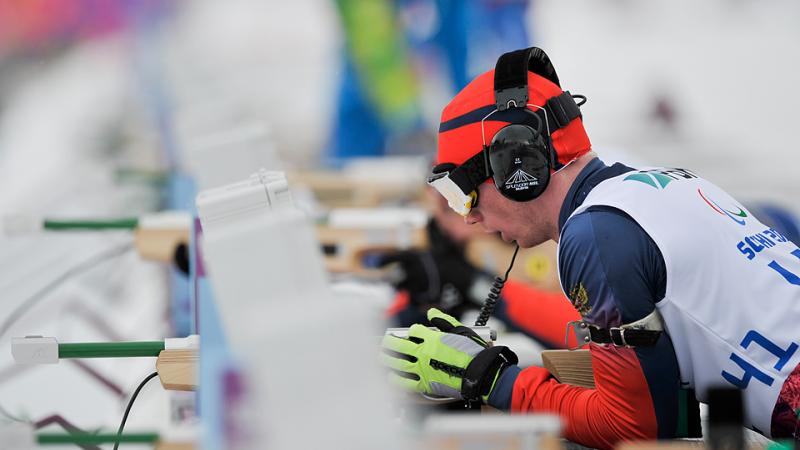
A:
[488,124,551,202]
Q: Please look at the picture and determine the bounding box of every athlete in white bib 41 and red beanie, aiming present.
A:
[382,48,800,448]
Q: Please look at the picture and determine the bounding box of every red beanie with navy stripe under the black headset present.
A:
[436,70,592,166]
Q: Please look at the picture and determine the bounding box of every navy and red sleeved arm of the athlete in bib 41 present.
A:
[489,208,680,448]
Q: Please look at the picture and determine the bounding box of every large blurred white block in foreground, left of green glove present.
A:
[197,171,403,450]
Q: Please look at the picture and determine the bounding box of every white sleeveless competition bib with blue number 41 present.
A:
[570,168,800,436]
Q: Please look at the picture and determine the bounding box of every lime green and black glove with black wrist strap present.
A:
[381,308,517,403]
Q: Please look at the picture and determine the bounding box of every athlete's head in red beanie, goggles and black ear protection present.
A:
[429,48,591,246]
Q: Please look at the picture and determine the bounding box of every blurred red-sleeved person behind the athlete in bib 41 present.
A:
[378,189,580,348]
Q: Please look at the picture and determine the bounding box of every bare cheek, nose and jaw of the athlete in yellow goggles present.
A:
[464,183,550,248]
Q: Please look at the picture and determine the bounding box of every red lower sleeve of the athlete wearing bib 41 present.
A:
[511,344,658,449]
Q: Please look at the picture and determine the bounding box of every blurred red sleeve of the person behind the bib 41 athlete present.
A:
[502,280,581,348]
